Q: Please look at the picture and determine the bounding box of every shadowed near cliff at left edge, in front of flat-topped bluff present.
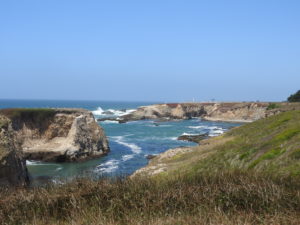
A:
[0,115,29,186]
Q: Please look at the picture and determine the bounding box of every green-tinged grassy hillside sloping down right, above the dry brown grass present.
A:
[151,111,300,177]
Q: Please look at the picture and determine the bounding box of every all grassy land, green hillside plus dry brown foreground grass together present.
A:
[0,111,300,225]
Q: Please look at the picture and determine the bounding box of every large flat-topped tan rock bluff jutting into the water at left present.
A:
[1,109,109,162]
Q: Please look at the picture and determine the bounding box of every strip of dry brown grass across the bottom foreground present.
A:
[0,171,300,224]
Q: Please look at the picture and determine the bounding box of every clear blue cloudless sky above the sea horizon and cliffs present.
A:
[0,0,300,101]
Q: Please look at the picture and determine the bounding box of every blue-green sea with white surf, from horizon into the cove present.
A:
[0,100,240,181]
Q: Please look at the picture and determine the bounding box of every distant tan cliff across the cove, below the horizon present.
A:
[119,102,269,122]
